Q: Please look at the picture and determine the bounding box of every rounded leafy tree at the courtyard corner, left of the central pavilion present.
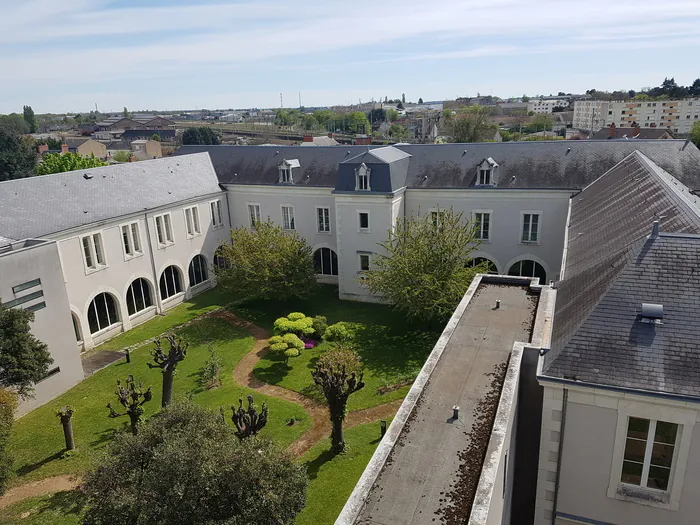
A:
[214,220,316,301]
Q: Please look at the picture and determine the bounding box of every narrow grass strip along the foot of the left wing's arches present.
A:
[96,288,229,350]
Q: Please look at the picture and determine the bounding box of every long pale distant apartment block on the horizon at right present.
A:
[574,97,700,135]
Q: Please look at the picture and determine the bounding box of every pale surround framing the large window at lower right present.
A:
[608,399,697,511]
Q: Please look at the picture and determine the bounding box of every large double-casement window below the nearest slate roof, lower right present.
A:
[620,417,679,491]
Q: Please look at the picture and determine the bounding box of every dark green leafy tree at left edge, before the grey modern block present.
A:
[0,303,53,392]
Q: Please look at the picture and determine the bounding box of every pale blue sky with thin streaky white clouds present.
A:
[0,0,700,113]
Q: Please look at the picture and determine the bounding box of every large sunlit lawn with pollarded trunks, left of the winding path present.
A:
[11,318,311,484]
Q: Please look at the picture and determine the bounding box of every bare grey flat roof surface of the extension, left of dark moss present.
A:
[357,284,536,525]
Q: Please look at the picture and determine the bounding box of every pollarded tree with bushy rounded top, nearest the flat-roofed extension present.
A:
[311,348,365,453]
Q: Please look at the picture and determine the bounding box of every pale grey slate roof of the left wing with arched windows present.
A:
[0,154,223,239]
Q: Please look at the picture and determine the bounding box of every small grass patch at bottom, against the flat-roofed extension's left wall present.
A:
[295,420,391,525]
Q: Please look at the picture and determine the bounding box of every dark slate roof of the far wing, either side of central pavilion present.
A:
[177,140,700,189]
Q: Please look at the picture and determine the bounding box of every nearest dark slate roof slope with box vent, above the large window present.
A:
[547,233,700,397]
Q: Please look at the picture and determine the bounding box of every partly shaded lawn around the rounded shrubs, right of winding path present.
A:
[246,286,439,410]
